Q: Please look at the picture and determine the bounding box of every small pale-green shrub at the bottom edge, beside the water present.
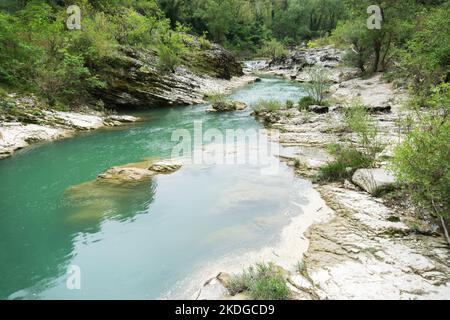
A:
[226,263,290,300]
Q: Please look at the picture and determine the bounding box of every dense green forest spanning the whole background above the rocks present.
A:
[0,0,449,103]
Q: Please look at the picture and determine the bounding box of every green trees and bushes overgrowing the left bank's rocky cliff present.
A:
[0,0,241,109]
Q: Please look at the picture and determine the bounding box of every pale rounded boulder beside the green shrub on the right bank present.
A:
[352,168,395,195]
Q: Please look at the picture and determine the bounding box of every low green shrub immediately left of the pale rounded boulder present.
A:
[314,145,374,182]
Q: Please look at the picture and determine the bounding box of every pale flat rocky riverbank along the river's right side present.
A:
[195,47,450,299]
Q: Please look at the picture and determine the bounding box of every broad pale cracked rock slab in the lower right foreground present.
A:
[302,185,450,300]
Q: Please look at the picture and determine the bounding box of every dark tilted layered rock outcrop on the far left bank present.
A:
[95,45,243,108]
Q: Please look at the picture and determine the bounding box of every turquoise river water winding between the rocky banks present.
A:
[0,78,310,299]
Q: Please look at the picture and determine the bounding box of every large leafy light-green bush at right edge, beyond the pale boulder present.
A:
[393,84,450,218]
